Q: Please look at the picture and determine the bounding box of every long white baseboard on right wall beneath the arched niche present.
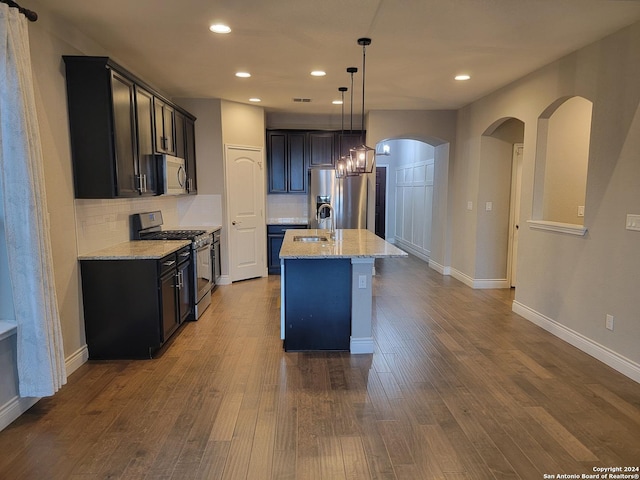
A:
[511,300,640,383]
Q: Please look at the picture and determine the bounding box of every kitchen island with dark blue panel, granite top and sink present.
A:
[280,229,407,353]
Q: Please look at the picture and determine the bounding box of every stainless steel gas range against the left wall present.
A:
[131,210,213,320]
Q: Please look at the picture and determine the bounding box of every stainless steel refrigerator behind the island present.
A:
[309,168,367,228]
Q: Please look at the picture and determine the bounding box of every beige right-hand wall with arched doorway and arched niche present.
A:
[450,19,640,370]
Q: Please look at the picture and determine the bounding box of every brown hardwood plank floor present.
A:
[0,253,640,480]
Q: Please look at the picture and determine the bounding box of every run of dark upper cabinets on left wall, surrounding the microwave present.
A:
[63,56,195,198]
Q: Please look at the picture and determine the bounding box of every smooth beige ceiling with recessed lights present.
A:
[28,0,640,114]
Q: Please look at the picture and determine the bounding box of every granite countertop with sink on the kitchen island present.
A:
[280,229,407,259]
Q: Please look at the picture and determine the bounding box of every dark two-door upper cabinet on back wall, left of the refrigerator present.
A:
[267,130,308,193]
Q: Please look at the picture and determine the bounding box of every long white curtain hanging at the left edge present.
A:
[0,4,67,397]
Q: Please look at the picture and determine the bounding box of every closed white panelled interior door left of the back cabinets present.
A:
[225,145,267,282]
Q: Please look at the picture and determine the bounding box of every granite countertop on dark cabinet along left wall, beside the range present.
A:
[78,240,191,260]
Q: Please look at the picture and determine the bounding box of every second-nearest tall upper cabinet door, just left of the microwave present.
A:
[135,85,158,195]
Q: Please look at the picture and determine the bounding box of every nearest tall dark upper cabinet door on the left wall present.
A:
[111,71,138,197]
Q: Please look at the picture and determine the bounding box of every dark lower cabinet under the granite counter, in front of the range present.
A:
[80,247,194,359]
